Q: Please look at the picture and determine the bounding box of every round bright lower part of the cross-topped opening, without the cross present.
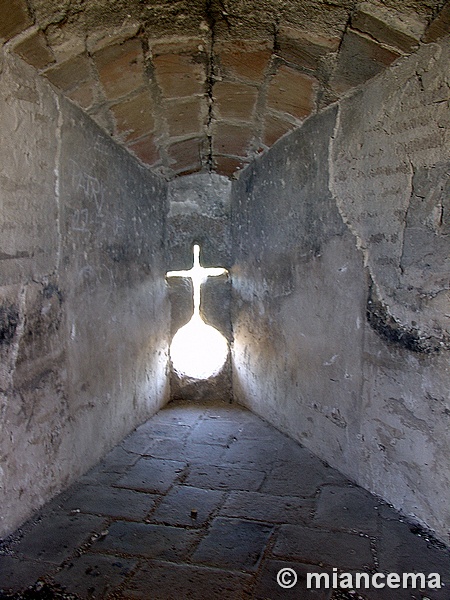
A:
[170,315,228,379]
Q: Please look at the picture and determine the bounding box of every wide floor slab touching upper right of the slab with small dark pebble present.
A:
[185,465,264,491]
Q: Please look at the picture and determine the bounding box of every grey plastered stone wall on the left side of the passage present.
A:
[0,55,170,535]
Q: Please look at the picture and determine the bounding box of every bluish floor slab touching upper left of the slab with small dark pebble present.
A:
[115,458,185,494]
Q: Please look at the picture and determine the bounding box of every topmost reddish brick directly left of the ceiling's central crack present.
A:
[153,54,206,98]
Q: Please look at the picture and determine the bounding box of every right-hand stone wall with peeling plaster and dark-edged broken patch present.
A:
[232,38,450,543]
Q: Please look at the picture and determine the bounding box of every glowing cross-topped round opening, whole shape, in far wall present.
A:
[167,244,228,379]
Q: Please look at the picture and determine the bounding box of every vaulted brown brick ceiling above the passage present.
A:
[0,0,450,178]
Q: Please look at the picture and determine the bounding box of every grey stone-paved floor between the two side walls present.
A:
[0,403,450,600]
